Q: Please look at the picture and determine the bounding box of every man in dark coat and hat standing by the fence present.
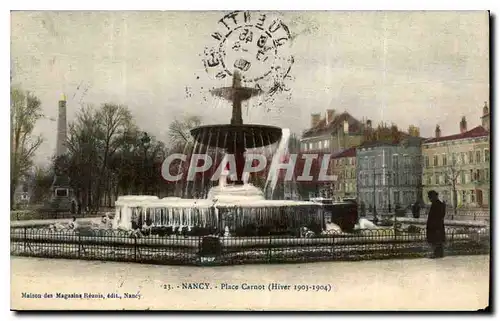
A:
[427,190,446,258]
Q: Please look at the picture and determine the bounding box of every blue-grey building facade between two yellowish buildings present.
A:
[356,134,423,213]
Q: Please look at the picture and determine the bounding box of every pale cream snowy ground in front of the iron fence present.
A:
[11,256,489,310]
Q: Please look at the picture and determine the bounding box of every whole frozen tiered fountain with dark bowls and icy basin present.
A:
[113,71,324,236]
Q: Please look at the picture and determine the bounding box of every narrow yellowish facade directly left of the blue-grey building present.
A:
[330,147,357,201]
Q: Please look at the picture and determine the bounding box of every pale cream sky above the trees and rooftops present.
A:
[11,11,489,162]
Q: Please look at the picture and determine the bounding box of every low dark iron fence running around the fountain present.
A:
[10,226,490,265]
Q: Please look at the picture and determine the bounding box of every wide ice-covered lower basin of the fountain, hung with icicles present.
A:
[113,192,324,234]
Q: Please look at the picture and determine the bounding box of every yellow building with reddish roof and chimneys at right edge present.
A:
[422,104,490,208]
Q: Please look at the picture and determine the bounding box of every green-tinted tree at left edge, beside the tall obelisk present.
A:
[10,88,43,208]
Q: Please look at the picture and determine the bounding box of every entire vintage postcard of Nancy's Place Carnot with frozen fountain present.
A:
[10,10,493,311]
